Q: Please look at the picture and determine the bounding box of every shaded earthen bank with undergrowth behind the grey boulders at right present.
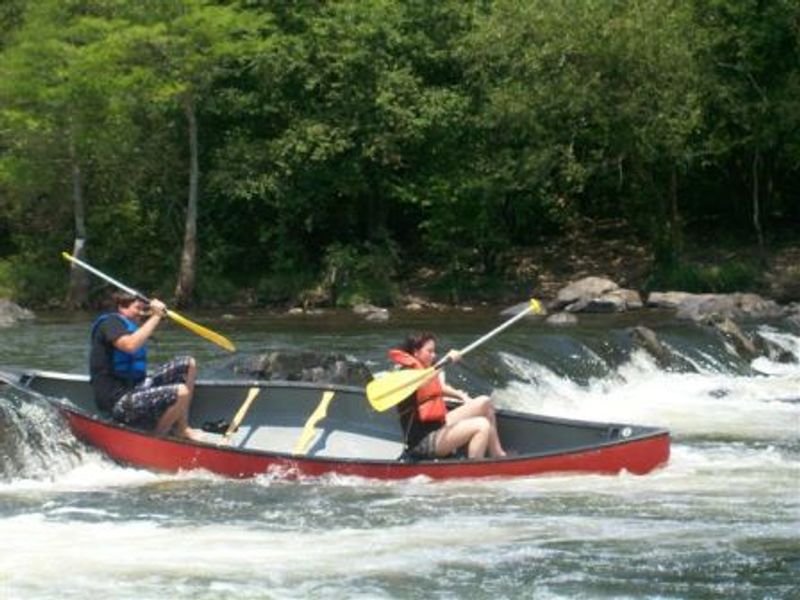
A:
[403,220,800,312]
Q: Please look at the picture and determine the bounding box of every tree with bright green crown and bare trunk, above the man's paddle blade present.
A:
[104,0,268,305]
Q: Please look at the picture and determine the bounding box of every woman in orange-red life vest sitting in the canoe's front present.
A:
[389,332,506,458]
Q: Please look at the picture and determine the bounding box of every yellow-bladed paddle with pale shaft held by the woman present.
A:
[367,298,542,411]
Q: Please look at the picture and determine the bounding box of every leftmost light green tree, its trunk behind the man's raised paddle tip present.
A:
[0,0,134,306]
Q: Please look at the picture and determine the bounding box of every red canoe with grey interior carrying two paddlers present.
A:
[4,371,670,479]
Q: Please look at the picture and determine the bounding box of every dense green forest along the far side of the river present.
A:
[0,0,800,306]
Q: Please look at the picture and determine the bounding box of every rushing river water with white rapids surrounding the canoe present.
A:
[0,311,800,599]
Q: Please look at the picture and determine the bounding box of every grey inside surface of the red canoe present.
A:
[15,371,664,461]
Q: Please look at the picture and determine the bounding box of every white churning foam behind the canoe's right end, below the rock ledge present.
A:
[494,351,800,439]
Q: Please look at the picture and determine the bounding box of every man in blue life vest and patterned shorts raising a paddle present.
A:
[89,291,202,440]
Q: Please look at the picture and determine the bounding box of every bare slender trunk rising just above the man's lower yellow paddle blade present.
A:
[175,95,200,306]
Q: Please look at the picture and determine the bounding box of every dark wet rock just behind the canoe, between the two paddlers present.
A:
[232,351,372,385]
